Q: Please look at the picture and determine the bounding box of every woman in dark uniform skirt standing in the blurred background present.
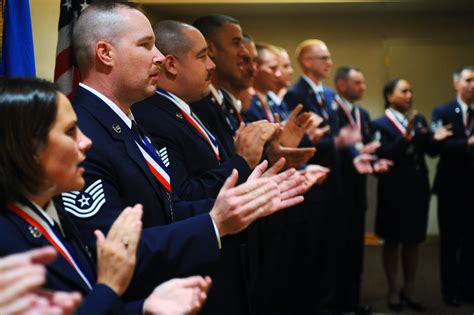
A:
[373,79,435,312]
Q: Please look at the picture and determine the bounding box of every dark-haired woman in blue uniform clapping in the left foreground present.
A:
[0,78,210,314]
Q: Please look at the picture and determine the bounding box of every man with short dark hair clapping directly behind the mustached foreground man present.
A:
[133,21,276,314]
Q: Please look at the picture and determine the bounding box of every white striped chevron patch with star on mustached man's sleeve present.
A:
[61,179,106,218]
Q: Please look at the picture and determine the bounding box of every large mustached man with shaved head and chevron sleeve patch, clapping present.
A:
[61,3,304,304]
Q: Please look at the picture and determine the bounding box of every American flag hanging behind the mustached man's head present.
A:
[54,0,91,99]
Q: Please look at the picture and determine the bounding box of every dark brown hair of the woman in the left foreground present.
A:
[0,77,59,207]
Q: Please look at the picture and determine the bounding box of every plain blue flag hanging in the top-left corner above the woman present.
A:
[0,0,36,77]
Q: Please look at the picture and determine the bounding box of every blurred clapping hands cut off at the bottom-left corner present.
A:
[0,246,82,315]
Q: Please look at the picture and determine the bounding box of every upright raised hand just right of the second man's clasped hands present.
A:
[280,104,313,148]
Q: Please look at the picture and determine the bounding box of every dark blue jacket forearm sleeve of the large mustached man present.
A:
[124,214,220,301]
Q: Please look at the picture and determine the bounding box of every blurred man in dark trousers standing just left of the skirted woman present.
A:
[334,66,390,310]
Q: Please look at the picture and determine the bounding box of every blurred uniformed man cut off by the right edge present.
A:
[432,66,474,306]
